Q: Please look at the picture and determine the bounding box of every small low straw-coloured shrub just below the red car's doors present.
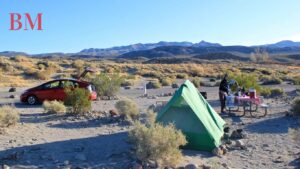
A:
[43,100,67,114]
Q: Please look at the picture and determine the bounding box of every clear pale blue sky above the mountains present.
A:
[0,0,300,54]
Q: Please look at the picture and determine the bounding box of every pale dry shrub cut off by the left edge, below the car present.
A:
[0,106,20,127]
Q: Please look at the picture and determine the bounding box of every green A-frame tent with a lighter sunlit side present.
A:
[156,80,225,151]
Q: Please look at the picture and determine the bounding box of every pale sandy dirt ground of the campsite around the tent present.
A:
[0,81,300,169]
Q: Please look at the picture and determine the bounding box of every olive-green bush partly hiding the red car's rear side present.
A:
[65,88,92,114]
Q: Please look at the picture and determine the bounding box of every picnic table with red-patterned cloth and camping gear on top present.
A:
[227,96,268,117]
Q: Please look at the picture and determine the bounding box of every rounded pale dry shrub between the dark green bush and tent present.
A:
[115,99,139,121]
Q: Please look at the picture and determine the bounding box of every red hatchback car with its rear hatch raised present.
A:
[20,69,97,105]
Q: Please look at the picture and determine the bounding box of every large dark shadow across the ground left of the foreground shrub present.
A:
[0,132,131,168]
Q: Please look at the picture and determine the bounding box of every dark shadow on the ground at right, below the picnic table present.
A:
[245,115,296,134]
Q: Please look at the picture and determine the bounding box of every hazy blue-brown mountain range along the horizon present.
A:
[0,40,300,62]
